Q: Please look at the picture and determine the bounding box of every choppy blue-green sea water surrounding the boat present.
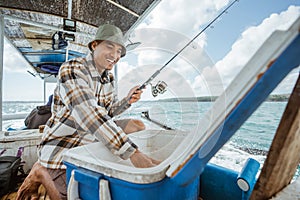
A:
[2,101,300,180]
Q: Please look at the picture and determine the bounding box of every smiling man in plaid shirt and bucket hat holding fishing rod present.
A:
[18,24,159,199]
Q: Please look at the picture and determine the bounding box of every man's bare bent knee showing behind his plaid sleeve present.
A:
[115,119,145,134]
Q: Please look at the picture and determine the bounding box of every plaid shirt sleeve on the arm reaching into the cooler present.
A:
[58,61,137,159]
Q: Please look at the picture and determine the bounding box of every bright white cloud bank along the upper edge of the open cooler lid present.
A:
[216,6,300,90]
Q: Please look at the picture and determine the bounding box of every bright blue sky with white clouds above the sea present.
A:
[3,0,300,101]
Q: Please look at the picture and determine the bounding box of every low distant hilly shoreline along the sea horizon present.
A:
[158,94,290,102]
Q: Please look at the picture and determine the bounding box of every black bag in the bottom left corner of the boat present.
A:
[0,156,21,197]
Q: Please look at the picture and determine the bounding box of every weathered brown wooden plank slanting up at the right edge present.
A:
[250,76,300,200]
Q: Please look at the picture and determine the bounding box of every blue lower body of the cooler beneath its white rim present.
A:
[64,162,200,200]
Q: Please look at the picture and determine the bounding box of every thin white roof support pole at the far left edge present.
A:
[0,15,4,131]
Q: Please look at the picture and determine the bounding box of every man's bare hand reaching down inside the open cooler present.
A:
[130,150,161,168]
